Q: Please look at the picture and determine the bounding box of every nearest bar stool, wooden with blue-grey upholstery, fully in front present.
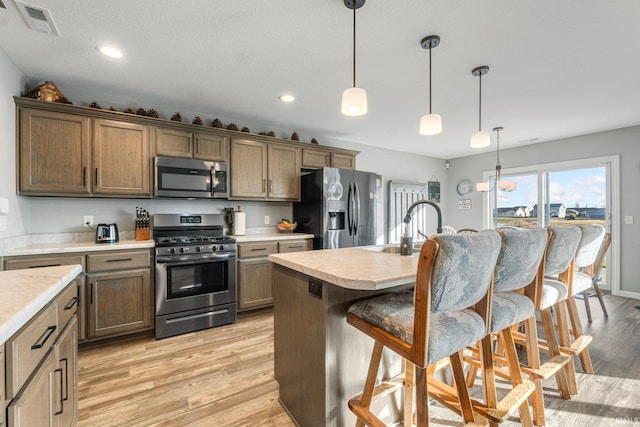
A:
[347,230,500,427]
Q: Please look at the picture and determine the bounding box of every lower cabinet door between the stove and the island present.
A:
[238,258,273,310]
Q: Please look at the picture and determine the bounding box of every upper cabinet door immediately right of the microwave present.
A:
[229,139,267,199]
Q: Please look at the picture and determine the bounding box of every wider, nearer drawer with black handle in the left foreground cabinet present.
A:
[6,304,58,400]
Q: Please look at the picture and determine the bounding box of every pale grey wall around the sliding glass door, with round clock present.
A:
[447,126,640,294]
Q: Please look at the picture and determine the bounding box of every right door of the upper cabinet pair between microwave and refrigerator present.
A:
[268,144,301,200]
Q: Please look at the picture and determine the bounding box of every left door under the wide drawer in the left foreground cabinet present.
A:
[7,350,57,427]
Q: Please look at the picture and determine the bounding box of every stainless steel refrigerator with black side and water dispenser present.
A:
[293,168,382,249]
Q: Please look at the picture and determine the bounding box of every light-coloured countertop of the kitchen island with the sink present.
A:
[269,248,418,290]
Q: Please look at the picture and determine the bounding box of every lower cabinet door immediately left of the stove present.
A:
[87,269,153,338]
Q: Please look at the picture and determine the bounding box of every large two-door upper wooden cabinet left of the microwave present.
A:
[17,103,151,197]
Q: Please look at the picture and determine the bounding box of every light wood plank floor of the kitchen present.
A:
[78,295,640,427]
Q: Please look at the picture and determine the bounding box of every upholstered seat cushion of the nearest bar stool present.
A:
[349,291,486,365]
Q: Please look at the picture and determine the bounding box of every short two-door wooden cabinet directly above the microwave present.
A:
[154,127,229,161]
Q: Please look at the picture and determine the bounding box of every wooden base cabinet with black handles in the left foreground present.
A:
[5,284,78,427]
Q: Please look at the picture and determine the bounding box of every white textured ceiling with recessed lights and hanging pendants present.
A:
[0,0,640,159]
